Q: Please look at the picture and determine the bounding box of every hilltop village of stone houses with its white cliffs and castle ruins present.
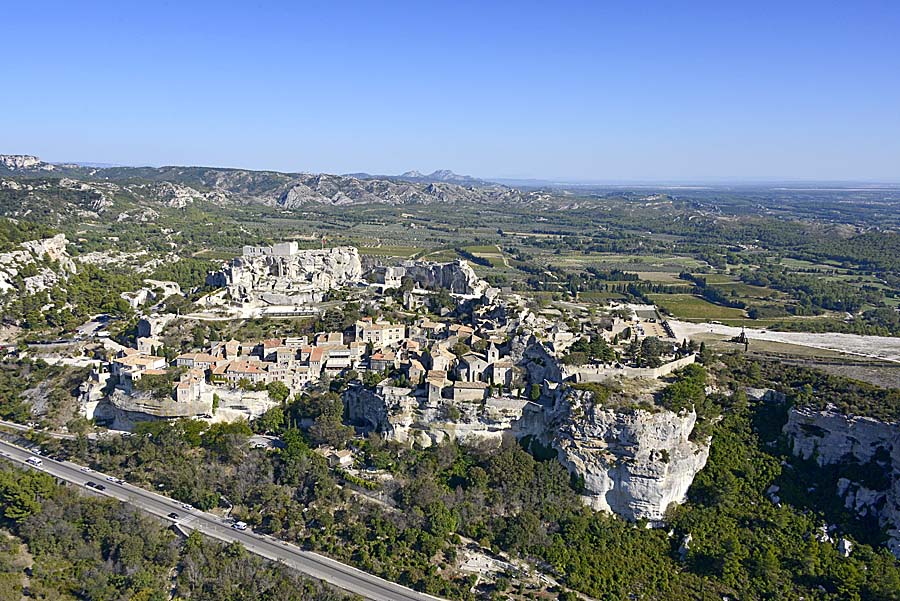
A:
[68,243,708,521]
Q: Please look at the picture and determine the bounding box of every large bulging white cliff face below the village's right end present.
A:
[553,394,709,523]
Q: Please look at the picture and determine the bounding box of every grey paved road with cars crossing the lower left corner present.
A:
[0,440,441,601]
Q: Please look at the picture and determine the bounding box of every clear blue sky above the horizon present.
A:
[0,1,900,181]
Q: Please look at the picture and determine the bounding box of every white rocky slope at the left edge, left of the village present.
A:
[0,234,76,294]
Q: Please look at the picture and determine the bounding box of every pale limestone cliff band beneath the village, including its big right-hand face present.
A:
[344,326,710,524]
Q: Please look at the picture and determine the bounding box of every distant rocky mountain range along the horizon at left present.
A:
[0,155,549,220]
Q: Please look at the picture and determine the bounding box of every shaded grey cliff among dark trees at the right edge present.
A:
[783,407,900,558]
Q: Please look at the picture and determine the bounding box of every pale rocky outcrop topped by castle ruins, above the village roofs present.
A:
[206,246,362,305]
